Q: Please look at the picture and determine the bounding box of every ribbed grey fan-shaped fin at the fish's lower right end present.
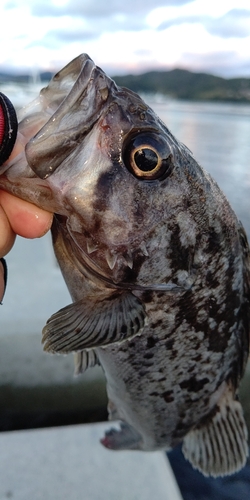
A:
[182,386,248,477]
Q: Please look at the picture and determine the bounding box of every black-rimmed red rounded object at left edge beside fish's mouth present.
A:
[0,92,18,165]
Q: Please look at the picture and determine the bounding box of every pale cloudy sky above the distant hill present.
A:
[0,0,250,77]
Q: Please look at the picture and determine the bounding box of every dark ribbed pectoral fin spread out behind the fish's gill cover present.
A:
[42,292,146,354]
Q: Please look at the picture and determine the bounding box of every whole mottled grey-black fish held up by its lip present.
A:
[0,54,250,477]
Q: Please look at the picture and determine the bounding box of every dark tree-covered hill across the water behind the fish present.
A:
[113,69,250,103]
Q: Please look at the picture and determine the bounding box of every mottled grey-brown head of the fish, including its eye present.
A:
[0,54,206,286]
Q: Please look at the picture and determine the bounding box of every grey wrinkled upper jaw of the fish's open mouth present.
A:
[26,54,114,179]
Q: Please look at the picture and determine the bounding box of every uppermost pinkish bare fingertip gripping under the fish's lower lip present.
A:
[1,191,53,238]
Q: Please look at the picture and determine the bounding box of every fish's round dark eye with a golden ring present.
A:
[123,132,173,180]
